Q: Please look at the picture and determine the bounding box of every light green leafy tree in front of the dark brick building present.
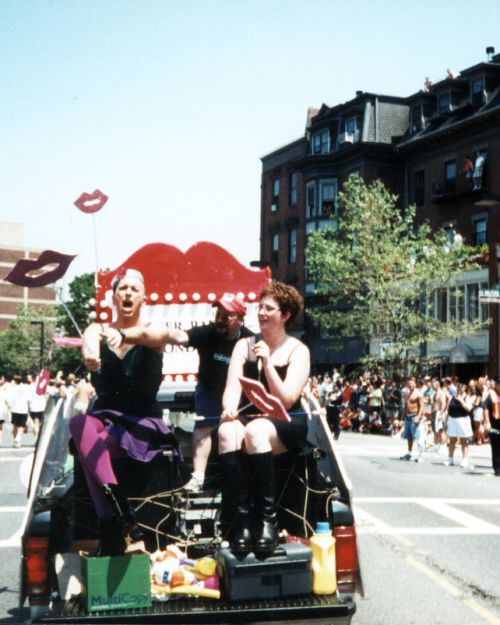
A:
[307,176,481,370]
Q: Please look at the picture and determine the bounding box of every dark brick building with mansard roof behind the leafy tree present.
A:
[261,48,500,377]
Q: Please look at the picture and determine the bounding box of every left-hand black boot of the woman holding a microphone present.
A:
[219,450,253,553]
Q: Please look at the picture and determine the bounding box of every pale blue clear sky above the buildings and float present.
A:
[0,0,500,280]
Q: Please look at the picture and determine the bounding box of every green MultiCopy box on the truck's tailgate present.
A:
[81,553,151,613]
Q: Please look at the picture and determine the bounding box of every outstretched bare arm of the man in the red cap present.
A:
[101,323,189,351]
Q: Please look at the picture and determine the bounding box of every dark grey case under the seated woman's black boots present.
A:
[217,543,312,601]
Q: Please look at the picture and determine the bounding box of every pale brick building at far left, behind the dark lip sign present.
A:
[0,222,56,331]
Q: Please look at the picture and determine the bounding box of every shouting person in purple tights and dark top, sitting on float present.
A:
[69,269,178,555]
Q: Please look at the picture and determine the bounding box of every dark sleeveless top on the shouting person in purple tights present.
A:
[92,340,163,416]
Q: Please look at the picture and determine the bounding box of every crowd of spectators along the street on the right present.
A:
[306,369,500,476]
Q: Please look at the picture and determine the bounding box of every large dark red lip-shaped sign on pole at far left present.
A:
[4,250,76,288]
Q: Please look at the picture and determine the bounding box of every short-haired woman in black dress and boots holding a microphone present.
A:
[218,281,310,555]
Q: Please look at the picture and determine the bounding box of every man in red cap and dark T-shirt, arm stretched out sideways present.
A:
[116,293,253,492]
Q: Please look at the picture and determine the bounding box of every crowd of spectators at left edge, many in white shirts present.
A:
[0,371,95,448]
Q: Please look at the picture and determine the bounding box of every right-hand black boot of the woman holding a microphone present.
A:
[248,451,278,556]
